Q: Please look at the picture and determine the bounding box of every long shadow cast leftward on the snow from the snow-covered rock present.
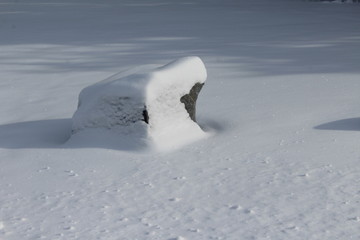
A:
[0,118,145,151]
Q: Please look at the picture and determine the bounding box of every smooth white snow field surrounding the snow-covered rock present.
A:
[0,0,360,240]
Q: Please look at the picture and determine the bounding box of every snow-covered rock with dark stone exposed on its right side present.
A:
[72,57,207,149]
